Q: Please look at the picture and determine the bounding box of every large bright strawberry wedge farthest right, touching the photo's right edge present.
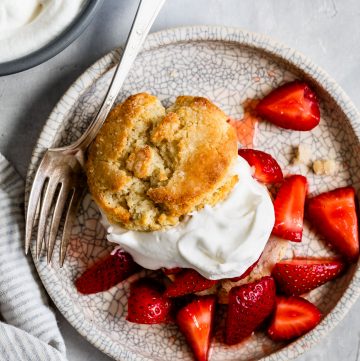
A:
[306,187,359,261]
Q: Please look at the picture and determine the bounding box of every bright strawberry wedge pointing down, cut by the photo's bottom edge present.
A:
[176,296,216,361]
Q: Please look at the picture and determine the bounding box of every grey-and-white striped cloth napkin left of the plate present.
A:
[0,154,66,361]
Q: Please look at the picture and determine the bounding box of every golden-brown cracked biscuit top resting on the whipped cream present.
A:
[87,93,237,231]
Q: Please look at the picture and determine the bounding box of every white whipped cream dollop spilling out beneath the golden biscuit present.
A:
[105,157,275,280]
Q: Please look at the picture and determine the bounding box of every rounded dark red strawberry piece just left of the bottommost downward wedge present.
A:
[126,278,171,324]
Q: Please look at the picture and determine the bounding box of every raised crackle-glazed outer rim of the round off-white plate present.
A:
[25,25,360,361]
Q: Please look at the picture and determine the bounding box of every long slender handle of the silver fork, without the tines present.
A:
[64,0,166,153]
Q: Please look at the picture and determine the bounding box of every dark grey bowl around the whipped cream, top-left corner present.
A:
[0,0,104,76]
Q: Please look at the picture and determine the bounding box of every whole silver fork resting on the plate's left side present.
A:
[25,0,166,266]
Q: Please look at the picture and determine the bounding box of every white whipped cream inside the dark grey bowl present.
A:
[0,0,84,63]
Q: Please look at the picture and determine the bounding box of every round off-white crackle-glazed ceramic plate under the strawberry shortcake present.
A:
[26,27,360,361]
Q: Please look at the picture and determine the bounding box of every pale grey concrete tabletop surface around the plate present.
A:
[0,0,360,361]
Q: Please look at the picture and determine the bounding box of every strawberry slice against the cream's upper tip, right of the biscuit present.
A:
[238,148,283,183]
